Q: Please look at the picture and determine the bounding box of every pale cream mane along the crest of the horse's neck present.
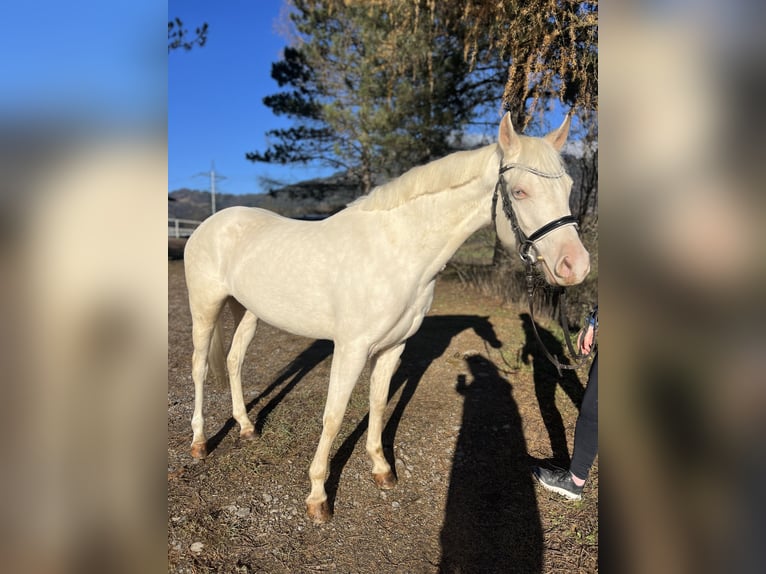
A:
[349,144,498,211]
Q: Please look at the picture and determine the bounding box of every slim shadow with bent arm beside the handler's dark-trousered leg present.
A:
[519,313,585,468]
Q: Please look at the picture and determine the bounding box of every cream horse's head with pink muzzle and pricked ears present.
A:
[493,114,590,285]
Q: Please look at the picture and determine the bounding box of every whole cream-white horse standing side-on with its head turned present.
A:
[185,110,590,523]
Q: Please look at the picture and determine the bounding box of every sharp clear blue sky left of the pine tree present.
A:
[168,0,331,194]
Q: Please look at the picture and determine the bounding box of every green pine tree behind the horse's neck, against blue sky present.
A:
[246,0,501,196]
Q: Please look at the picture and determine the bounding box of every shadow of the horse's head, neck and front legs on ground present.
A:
[325,315,502,511]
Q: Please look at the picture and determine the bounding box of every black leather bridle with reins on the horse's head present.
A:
[492,163,595,377]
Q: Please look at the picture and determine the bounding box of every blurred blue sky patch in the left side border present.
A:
[0,0,167,127]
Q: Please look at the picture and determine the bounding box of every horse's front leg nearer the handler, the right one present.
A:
[367,343,404,490]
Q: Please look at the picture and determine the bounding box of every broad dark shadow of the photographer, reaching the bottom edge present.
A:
[439,355,543,573]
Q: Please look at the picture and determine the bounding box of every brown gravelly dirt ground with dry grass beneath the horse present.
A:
[168,261,598,573]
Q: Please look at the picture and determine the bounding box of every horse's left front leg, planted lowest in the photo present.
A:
[306,344,367,524]
